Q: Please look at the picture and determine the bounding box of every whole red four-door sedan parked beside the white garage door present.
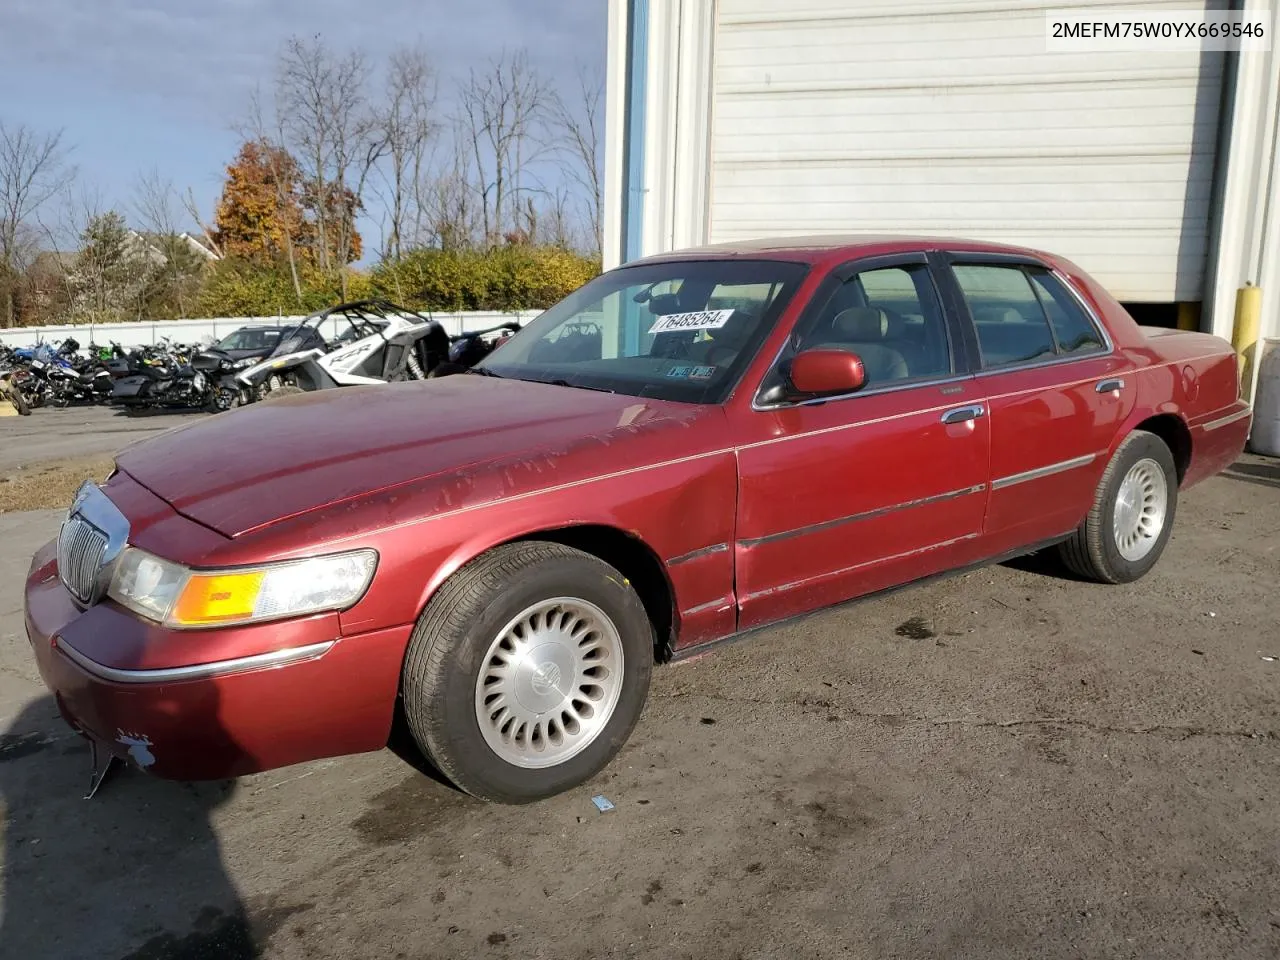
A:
[26,238,1251,803]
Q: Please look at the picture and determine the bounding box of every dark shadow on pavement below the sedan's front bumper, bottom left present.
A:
[0,696,282,960]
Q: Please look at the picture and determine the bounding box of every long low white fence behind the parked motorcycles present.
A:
[0,310,539,347]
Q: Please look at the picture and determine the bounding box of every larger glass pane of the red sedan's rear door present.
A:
[952,264,1057,367]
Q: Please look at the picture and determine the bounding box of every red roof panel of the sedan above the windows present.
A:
[632,233,1046,264]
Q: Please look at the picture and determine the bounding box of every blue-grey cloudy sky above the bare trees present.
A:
[0,0,607,252]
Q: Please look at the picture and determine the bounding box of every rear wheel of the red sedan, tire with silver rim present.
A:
[1059,430,1178,584]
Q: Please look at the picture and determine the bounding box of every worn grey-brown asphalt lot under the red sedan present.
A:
[0,417,1280,960]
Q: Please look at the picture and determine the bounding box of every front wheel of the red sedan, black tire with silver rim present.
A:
[401,541,654,804]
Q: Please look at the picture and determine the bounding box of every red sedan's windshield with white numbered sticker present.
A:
[480,260,808,403]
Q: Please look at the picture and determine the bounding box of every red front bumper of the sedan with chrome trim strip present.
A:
[26,544,411,780]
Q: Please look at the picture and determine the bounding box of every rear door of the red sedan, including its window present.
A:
[940,253,1137,554]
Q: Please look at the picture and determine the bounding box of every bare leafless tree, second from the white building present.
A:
[458,50,549,246]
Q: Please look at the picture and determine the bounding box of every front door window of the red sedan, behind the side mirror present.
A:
[796,264,954,385]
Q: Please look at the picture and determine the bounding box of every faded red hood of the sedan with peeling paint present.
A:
[116,376,705,536]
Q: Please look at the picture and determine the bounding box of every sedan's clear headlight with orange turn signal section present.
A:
[108,548,378,628]
